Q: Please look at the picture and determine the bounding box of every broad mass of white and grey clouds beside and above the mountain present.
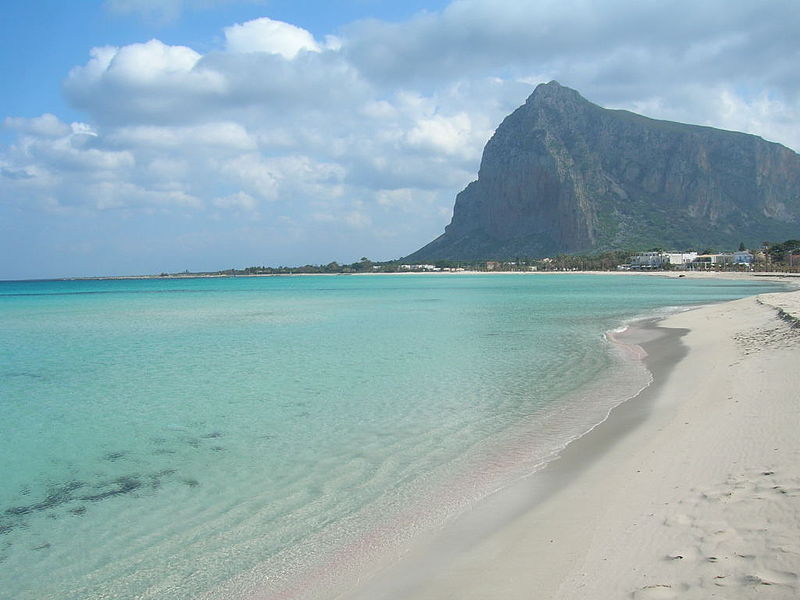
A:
[0,0,800,276]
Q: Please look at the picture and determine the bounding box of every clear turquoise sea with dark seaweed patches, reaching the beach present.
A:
[0,274,780,600]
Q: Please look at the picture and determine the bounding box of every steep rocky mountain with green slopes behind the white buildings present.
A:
[405,81,800,261]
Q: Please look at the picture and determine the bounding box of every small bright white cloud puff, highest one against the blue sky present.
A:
[225,17,320,60]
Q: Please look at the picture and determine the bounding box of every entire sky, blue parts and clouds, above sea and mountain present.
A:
[0,0,800,279]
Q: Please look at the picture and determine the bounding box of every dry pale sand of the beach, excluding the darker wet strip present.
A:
[554,292,800,598]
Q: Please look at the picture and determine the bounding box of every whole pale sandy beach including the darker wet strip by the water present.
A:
[355,278,800,600]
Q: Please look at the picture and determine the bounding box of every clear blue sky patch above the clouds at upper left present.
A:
[0,0,447,134]
